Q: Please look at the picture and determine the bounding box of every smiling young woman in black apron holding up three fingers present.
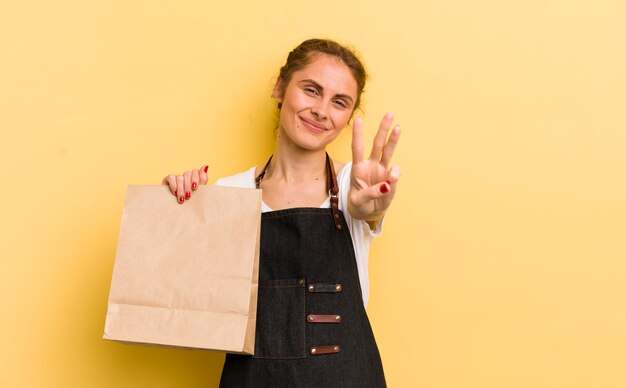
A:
[163,39,400,387]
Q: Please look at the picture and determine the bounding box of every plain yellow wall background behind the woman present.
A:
[0,0,626,388]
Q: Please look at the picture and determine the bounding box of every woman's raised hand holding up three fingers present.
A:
[348,113,400,225]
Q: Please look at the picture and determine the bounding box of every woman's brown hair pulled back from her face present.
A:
[278,39,367,113]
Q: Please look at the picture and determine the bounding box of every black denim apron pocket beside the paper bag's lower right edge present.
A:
[253,279,306,359]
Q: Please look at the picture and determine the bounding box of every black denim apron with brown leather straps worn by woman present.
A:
[220,156,386,388]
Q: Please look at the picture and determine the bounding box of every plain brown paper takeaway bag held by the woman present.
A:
[104,186,261,354]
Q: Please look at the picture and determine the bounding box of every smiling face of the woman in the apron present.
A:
[274,54,357,151]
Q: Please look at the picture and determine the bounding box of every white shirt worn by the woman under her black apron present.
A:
[215,162,382,306]
